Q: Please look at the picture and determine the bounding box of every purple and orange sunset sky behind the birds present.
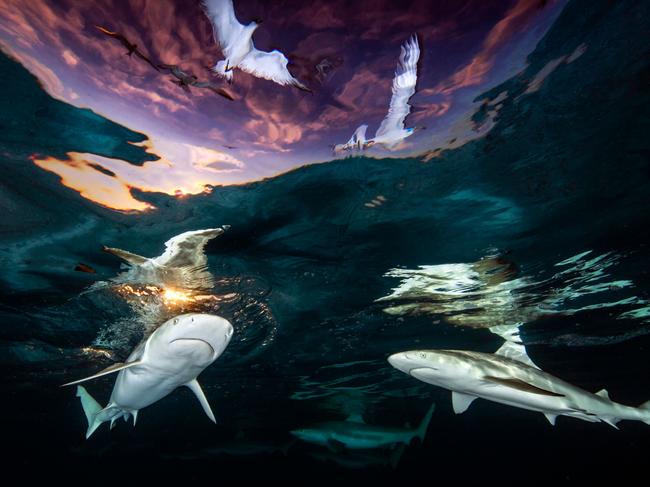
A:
[0,0,565,211]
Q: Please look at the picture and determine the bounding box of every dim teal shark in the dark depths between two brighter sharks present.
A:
[291,405,435,451]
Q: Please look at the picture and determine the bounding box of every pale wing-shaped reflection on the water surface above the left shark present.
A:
[103,225,230,289]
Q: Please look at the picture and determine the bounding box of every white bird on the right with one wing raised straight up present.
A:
[334,35,420,152]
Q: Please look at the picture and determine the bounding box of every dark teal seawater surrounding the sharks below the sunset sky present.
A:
[0,1,650,483]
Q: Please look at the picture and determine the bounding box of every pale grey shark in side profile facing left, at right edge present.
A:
[388,350,650,428]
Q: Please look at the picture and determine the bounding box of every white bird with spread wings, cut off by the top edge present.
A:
[203,0,311,92]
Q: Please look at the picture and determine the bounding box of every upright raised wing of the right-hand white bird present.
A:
[375,36,420,137]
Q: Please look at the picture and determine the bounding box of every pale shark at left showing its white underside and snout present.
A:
[64,314,233,438]
